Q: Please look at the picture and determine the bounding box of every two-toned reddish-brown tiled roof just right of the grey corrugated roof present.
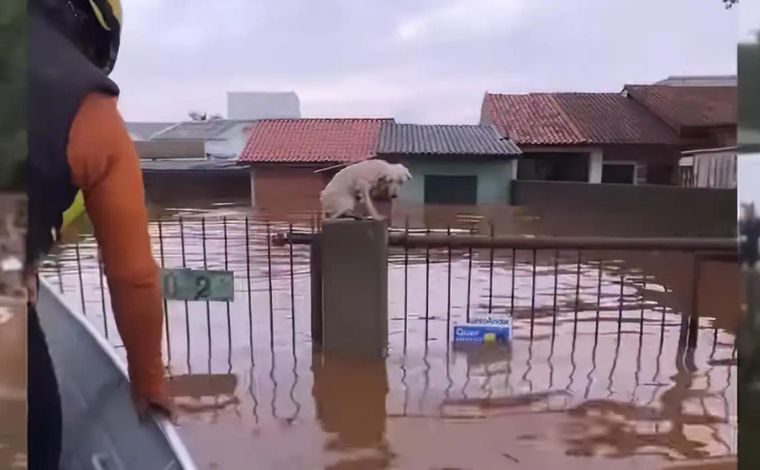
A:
[483,93,678,145]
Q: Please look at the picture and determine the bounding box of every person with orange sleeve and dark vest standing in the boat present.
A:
[26,0,172,470]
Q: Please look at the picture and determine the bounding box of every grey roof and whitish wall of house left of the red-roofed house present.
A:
[150,119,256,160]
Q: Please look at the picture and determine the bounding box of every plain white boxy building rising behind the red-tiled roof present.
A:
[227,91,301,120]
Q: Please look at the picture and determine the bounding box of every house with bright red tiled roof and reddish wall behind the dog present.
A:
[239,119,392,211]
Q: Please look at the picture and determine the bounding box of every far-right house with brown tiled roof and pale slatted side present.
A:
[623,80,738,188]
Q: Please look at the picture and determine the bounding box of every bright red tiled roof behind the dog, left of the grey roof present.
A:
[240,119,392,163]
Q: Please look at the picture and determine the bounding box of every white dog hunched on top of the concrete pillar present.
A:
[319,160,412,220]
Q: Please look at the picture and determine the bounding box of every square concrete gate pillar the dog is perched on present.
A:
[320,220,388,357]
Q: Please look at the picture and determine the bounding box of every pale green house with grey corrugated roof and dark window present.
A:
[377,121,520,205]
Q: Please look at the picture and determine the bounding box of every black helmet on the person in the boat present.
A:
[29,0,122,74]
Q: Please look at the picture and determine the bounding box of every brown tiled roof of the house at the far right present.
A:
[625,85,737,131]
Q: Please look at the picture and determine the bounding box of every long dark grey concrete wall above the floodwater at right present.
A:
[512,181,736,237]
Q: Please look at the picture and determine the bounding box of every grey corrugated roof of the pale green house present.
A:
[378,122,522,156]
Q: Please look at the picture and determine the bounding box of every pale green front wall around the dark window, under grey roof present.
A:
[399,159,515,204]
